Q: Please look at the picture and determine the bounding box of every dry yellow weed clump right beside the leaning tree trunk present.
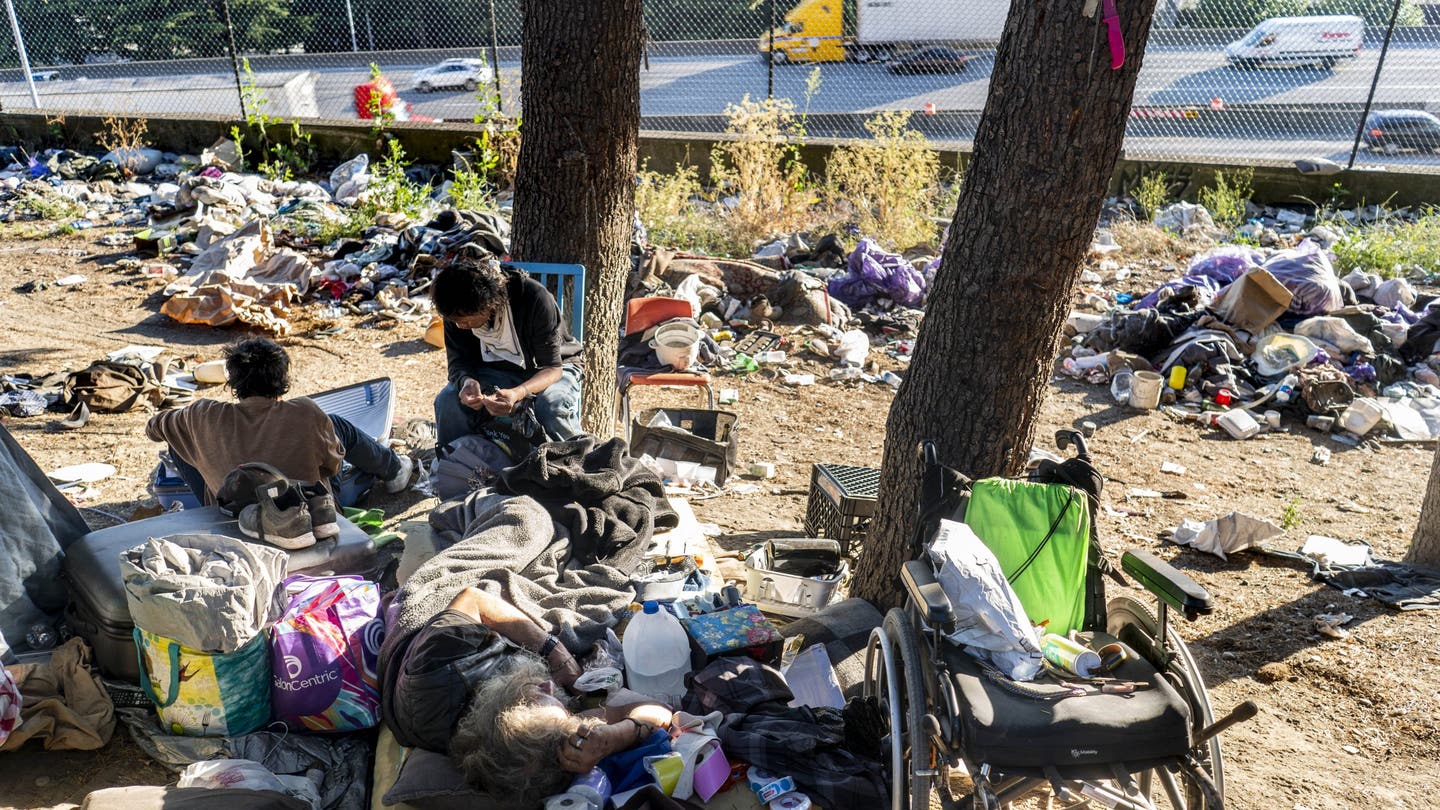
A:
[825,110,953,249]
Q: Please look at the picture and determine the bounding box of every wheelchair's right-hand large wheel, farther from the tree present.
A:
[1106,597,1225,810]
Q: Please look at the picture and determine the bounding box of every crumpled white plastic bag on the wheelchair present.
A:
[929,520,1044,680]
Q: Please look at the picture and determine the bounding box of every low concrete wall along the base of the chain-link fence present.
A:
[0,110,1440,206]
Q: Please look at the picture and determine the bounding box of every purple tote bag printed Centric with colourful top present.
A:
[269,575,384,731]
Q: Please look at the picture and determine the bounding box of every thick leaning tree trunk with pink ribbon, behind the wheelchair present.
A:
[855,0,1155,607]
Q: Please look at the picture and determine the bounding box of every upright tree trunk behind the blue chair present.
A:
[511,0,641,437]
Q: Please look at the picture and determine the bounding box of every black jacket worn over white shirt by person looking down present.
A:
[445,271,583,386]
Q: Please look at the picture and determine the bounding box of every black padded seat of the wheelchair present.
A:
[942,633,1192,778]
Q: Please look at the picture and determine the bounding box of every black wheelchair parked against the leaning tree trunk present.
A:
[864,431,1257,810]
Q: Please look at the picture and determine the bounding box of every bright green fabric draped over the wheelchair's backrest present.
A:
[965,479,1090,636]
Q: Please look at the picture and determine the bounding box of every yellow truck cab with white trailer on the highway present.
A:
[759,0,1009,63]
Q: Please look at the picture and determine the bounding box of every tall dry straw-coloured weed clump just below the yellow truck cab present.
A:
[710,95,812,252]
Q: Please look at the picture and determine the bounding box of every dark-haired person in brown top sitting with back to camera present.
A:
[145,337,415,513]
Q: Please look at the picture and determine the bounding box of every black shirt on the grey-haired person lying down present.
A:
[380,610,523,754]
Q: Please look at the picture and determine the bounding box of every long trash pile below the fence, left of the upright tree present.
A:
[0,138,510,334]
